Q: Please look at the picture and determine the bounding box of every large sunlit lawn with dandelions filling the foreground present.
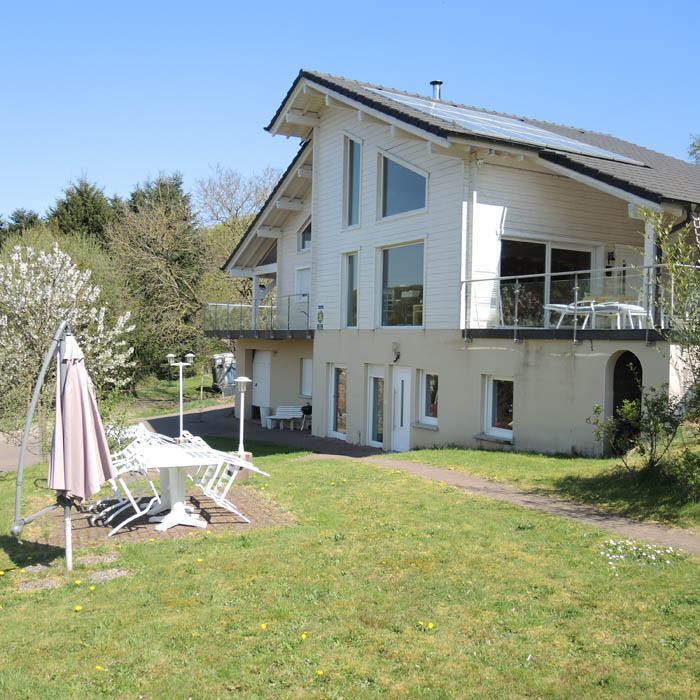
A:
[0,438,700,699]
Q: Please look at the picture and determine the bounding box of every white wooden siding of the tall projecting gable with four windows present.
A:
[312,109,463,329]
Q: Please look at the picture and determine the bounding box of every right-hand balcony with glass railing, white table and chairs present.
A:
[463,265,678,342]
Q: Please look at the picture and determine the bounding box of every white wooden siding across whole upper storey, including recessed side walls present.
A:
[277,113,642,330]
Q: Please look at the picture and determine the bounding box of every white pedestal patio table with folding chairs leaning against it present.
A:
[140,443,218,532]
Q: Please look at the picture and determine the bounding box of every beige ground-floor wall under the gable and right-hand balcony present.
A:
[313,330,670,455]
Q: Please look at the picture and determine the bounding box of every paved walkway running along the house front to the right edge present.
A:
[150,407,700,555]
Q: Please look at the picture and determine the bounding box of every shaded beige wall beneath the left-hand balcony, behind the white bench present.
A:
[236,338,313,418]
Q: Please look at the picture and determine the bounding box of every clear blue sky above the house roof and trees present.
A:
[0,0,700,216]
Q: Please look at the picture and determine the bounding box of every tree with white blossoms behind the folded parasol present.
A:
[0,243,134,442]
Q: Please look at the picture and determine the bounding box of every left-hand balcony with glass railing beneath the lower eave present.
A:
[202,294,314,339]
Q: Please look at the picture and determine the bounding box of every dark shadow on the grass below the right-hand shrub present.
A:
[552,467,687,522]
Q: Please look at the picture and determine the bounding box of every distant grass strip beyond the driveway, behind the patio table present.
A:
[119,372,232,419]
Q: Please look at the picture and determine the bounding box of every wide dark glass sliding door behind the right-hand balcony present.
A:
[501,240,591,327]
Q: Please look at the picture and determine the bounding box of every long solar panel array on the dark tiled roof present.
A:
[366,87,643,165]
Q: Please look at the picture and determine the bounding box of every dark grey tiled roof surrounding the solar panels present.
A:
[267,70,700,203]
